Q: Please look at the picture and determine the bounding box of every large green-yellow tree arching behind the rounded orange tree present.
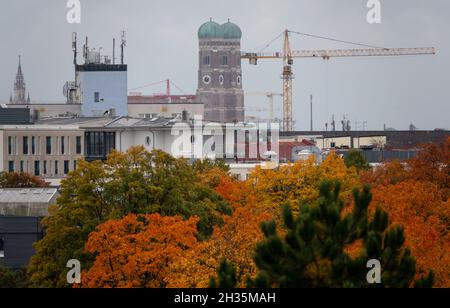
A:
[29,147,231,287]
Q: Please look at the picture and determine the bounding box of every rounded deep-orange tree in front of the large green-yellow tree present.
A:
[82,214,198,288]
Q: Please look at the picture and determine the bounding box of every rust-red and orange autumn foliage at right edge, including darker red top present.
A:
[362,140,450,288]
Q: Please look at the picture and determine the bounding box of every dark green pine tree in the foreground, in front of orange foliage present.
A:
[250,182,433,288]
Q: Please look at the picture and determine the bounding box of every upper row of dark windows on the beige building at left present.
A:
[8,136,82,155]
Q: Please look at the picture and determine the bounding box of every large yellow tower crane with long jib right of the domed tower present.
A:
[241,30,436,131]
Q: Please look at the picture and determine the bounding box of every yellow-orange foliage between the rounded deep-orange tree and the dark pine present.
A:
[166,207,270,288]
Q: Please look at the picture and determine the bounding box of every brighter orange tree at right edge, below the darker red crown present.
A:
[372,181,450,288]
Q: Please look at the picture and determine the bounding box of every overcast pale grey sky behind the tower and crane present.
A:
[0,0,450,130]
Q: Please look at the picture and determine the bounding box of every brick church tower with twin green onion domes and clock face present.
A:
[197,20,245,123]
